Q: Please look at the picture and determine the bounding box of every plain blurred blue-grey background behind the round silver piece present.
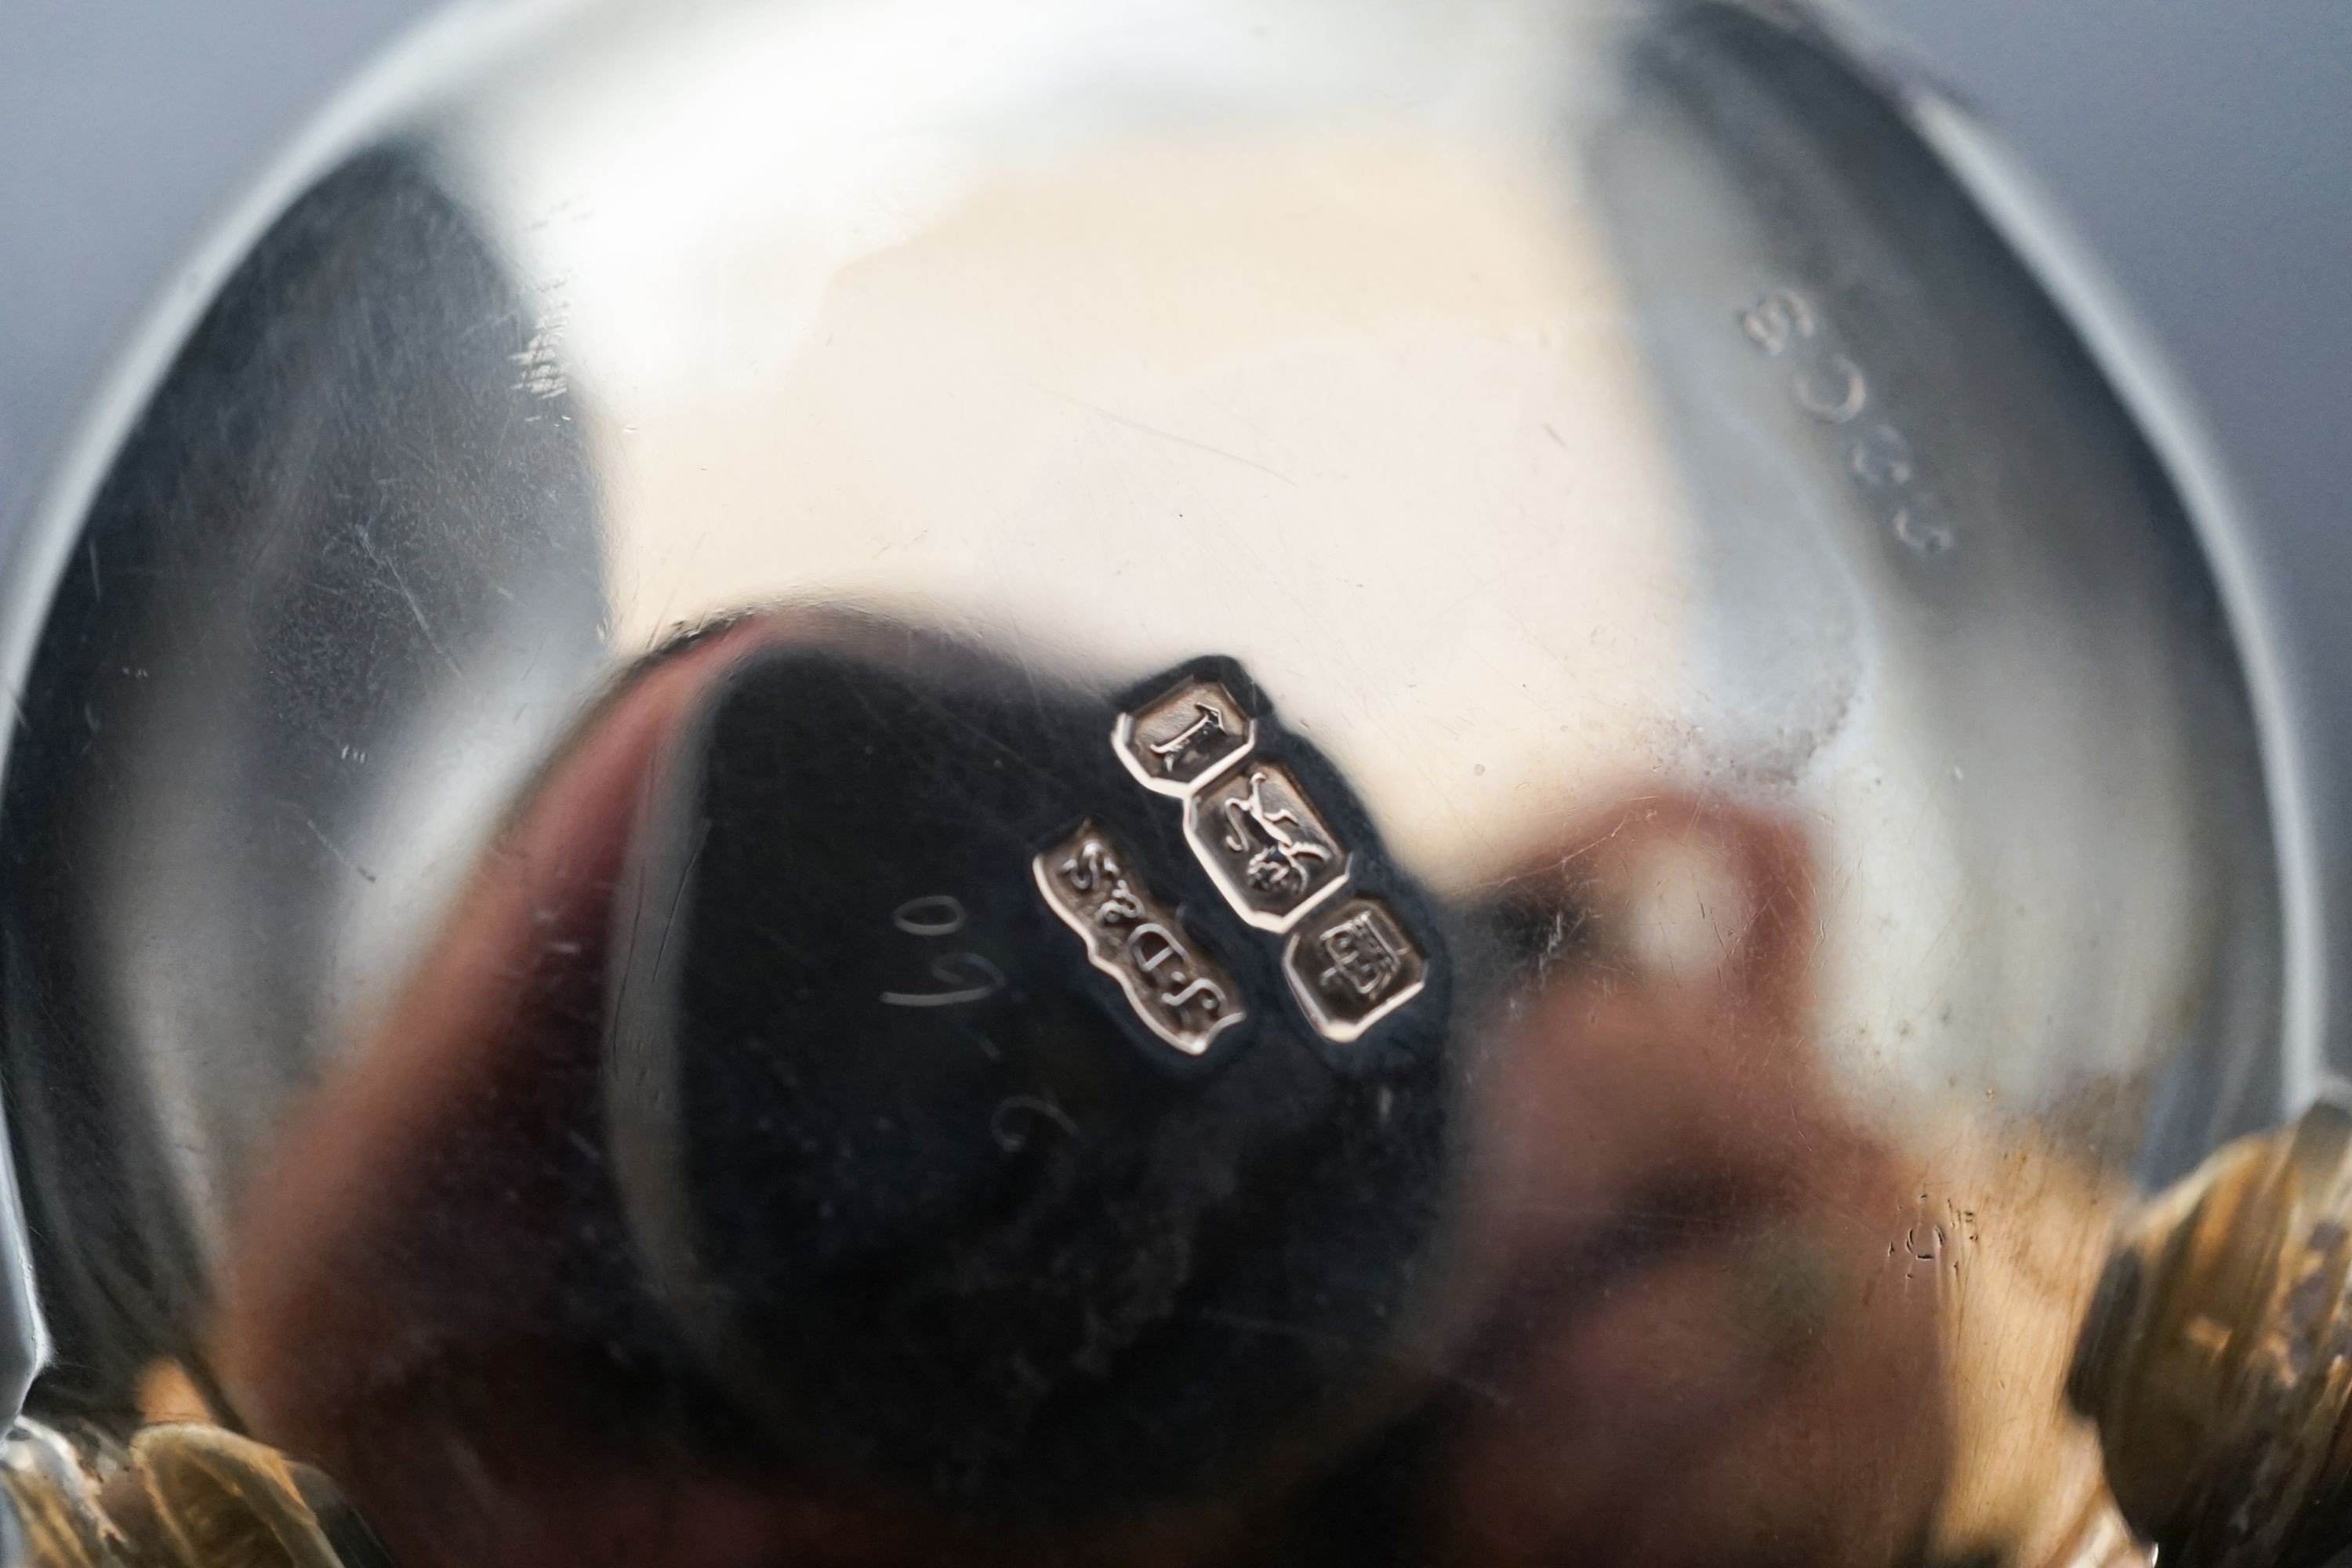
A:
[0,0,2352,1044]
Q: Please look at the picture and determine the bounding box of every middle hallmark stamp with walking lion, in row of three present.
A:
[1183,760,1348,931]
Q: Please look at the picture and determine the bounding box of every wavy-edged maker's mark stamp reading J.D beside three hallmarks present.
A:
[1030,822,1249,1055]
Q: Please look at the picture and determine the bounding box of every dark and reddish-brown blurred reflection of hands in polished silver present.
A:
[188,612,2117,1563]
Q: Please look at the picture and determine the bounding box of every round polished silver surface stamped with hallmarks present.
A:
[0,0,2312,1563]
